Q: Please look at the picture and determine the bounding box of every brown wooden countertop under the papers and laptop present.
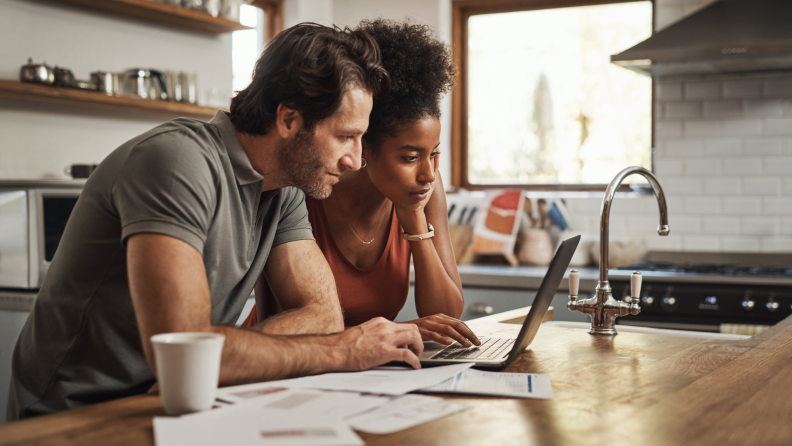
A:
[0,310,792,446]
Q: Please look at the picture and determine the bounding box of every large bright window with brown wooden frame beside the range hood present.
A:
[453,0,652,189]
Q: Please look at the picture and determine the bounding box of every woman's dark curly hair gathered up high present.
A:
[358,19,457,156]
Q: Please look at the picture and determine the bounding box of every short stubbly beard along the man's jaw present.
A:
[278,129,333,200]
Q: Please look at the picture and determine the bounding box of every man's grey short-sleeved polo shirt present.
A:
[8,111,313,420]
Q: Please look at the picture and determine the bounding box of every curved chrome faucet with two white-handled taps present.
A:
[567,167,669,335]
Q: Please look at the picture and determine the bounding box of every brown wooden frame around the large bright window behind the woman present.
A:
[451,0,655,191]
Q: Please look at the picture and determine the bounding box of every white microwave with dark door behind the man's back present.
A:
[0,180,85,290]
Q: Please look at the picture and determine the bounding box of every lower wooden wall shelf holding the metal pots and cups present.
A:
[0,79,217,120]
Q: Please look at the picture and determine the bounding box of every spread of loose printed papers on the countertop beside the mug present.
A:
[154,364,553,446]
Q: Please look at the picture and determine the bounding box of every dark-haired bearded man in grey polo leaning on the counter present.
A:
[8,24,422,420]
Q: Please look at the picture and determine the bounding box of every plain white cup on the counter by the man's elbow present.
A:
[151,333,225,415]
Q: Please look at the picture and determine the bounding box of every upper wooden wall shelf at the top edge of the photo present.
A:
[44,0,253,34]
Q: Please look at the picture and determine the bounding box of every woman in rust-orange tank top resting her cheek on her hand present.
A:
[244,20,480,346]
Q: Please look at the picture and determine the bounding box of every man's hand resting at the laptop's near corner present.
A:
[340,317,423,370]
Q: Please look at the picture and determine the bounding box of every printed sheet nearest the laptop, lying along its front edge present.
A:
[421,369,553,399]
